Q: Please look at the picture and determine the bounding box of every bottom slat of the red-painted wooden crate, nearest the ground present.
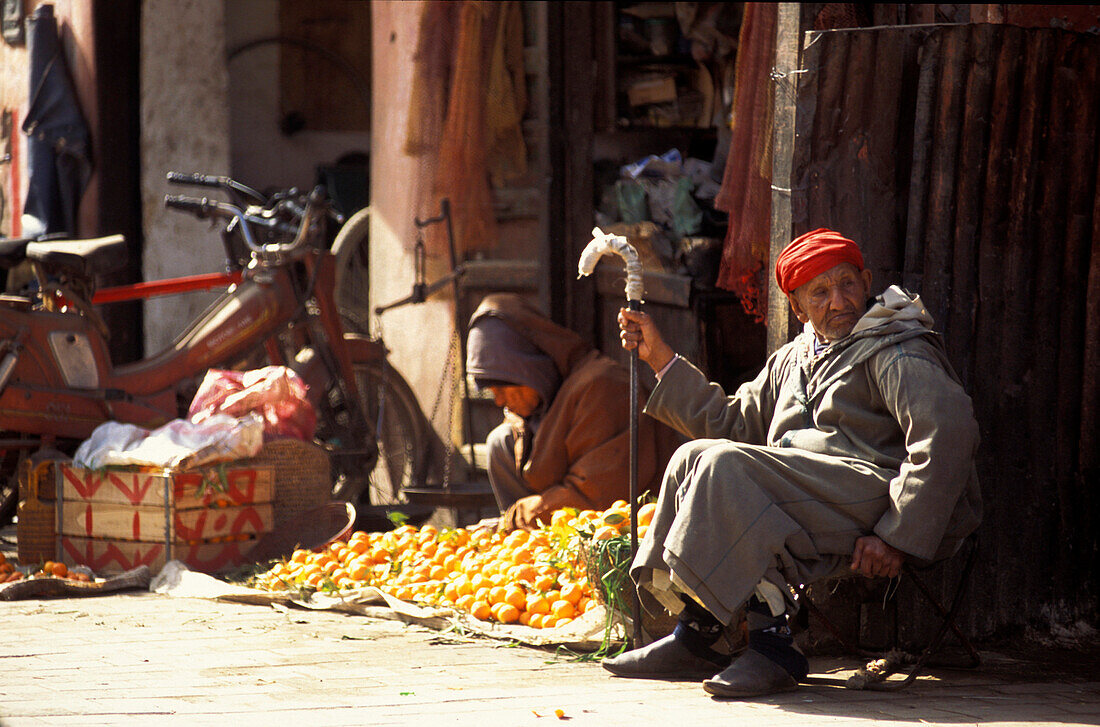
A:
[58,536,254,575]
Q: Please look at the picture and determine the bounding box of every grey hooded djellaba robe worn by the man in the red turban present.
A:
[631,286,981,623]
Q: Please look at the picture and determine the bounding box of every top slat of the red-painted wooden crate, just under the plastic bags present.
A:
[58,464,275,509]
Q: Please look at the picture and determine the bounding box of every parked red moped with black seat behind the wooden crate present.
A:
[0,174,431,524]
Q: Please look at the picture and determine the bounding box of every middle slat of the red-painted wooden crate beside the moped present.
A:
[59,500,275,543]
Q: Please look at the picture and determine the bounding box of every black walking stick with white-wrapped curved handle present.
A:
[578,228,645,649]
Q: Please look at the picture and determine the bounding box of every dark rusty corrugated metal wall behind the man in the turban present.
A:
[792,19,1100,636]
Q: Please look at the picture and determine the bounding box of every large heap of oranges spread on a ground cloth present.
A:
[253,500,655,628]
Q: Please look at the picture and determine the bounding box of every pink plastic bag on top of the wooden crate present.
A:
[187,366,317,441]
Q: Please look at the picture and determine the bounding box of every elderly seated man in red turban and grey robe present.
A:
[603,229,981,697]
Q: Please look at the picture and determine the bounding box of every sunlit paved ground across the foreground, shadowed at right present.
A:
[0,592,1100,727]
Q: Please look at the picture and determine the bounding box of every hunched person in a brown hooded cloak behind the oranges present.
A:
[466,294,680,530]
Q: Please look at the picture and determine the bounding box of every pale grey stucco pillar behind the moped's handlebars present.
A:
[141,0,230,354]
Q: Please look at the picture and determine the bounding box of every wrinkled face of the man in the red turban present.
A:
[789,263,871,343]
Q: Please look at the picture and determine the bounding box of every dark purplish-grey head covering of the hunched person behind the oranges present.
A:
[466,316,561,416]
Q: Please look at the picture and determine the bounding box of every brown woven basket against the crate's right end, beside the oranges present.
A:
[248,439,332,531]
